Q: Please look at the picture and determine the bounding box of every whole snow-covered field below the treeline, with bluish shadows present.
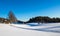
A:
[0,23,60,36]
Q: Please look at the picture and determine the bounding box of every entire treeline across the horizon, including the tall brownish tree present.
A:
[0,11,60,23]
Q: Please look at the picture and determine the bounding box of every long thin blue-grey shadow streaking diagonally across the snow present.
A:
[11,25,60,33]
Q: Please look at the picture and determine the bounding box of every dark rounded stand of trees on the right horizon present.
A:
[27,16,60,23]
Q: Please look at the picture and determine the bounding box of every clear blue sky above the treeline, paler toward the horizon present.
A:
[0,0,60,21]
